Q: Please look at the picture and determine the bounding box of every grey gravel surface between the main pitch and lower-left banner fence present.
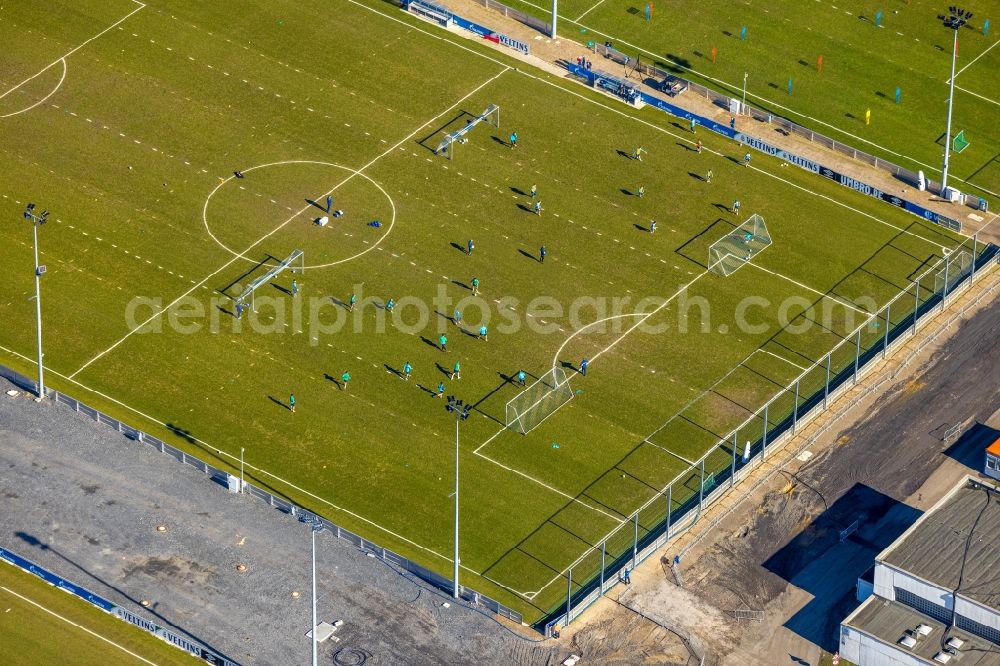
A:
[0,380,568,666]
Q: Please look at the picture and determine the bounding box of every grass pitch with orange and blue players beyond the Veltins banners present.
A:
[507,0,1000,201]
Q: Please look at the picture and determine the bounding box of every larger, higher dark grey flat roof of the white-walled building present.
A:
[879,479,1000,610]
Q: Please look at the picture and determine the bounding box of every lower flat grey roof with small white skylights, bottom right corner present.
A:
[844,596,1000,666]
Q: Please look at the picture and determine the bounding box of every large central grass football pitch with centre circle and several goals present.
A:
[0,0,980,621]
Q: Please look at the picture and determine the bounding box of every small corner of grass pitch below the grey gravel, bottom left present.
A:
[0,562,199,666]
